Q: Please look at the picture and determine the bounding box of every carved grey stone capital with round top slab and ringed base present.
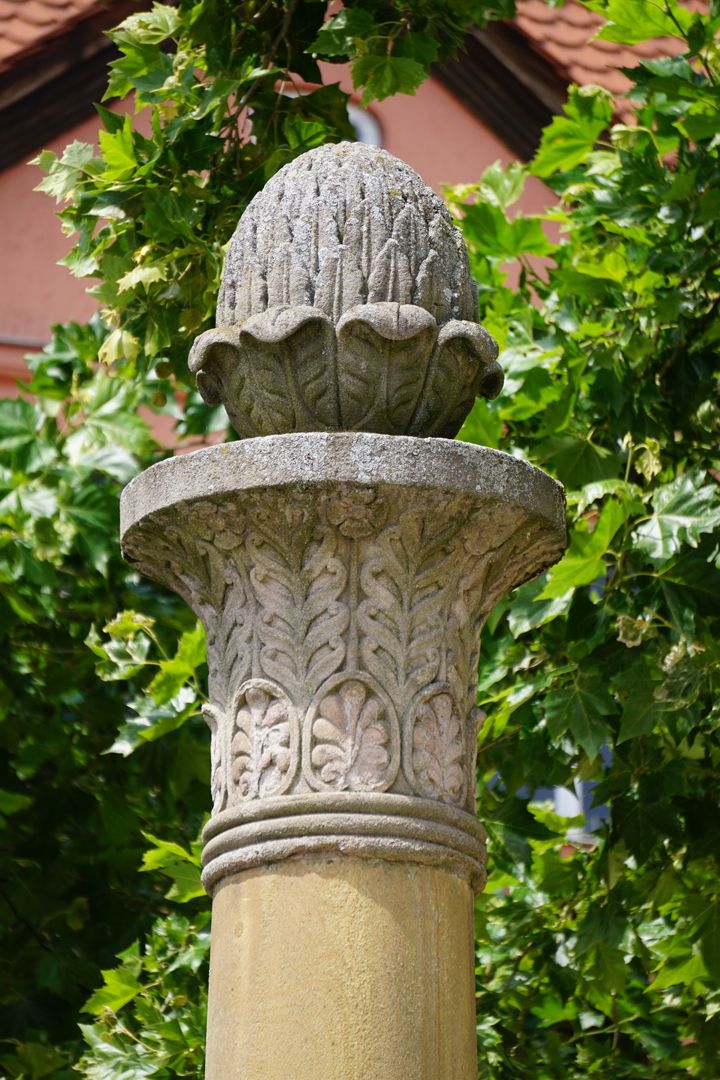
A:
[122,433,565,889]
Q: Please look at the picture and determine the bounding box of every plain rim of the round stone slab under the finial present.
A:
[120,423,566,537]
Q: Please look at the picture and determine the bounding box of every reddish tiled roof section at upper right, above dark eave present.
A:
[514,0,707,119]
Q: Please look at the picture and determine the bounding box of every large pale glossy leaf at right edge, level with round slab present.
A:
[635,472,720,563]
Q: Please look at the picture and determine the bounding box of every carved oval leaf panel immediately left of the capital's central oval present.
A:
[230,678,299,801]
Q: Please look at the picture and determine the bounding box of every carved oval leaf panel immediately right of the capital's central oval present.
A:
[403,683,467,806]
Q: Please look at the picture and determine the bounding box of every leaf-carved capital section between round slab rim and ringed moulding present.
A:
[126,484,561,812]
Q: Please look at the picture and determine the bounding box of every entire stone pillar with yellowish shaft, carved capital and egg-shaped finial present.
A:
[122,145,565,1080]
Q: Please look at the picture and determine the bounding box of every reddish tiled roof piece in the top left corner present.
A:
[0,0,102,71]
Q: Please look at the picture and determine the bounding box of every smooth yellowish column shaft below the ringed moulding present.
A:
[206,855,477,1080]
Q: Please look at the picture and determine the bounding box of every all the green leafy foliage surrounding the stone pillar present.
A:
[0,0,720,1080]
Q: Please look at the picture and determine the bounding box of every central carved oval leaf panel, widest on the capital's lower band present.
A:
[303,672,399,792]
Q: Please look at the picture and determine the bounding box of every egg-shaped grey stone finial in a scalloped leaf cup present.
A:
[189,143,503,438]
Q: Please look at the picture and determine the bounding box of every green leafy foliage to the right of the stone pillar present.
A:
[449,6,720,1078]
